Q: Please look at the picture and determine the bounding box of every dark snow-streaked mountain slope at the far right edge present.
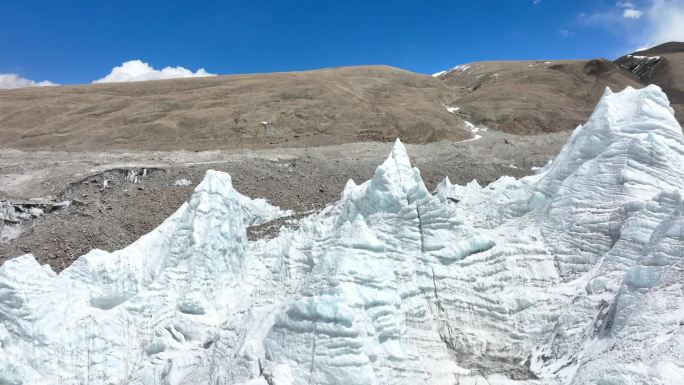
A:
[615,42,684,122]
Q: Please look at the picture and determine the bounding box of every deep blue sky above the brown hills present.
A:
[0,0,684,84]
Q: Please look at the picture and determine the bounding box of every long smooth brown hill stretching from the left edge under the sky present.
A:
[0,66,471,150]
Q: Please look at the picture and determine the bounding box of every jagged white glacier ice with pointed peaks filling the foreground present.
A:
[0,86,684,385]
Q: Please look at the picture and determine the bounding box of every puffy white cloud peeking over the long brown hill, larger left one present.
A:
[93,60,216,83]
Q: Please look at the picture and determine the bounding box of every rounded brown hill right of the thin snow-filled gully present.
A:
[436,59,641,134]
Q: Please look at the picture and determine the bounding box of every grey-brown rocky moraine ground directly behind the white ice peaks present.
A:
[0,131,568,271]
